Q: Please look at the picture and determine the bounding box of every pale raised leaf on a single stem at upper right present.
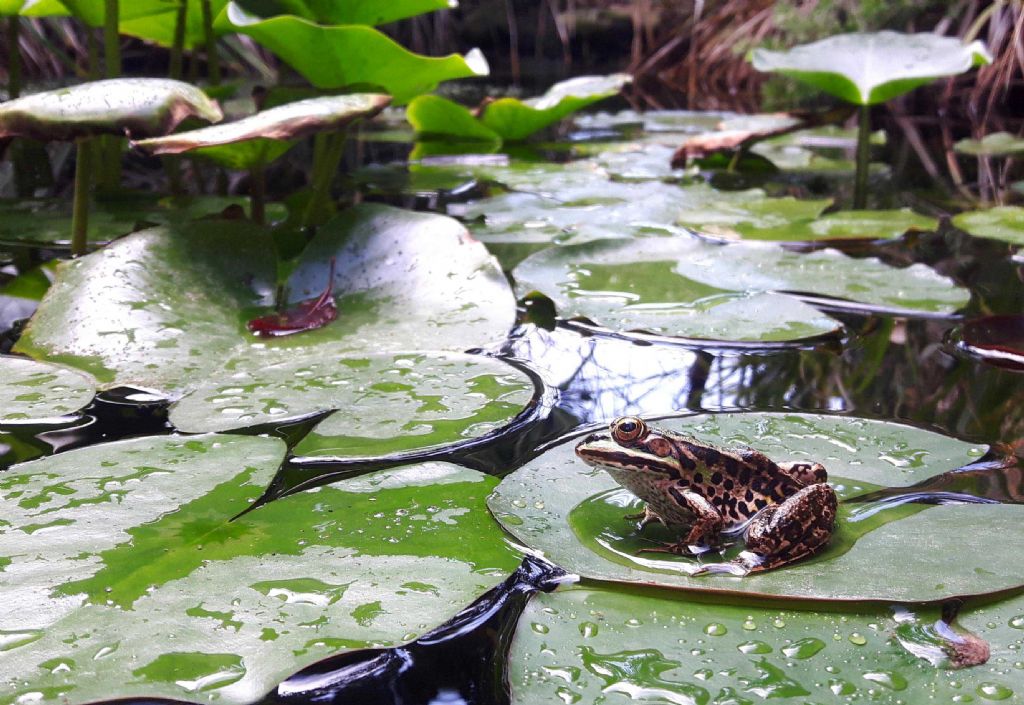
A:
[751,30,992,106]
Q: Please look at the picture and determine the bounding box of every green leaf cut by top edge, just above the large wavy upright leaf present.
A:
[224,0,448,26]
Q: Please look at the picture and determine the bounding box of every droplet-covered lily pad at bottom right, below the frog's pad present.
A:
[509,588,1024,705]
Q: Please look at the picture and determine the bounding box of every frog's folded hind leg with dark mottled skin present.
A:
[700,483,838,575]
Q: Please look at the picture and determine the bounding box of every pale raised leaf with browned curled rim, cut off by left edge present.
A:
[0,78,223,141]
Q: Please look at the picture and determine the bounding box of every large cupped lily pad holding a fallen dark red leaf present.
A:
[17,205,515,392]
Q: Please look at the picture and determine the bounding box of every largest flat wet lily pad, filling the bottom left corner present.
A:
[0,434,517,705]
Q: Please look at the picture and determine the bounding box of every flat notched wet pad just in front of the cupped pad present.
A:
[170,353,534,448]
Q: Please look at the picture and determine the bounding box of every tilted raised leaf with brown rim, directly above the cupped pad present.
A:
[132,93,391,169]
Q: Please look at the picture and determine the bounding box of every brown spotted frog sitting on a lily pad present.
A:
[575,416,839,576]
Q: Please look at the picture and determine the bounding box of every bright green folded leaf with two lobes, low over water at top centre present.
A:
[409,74,633,141]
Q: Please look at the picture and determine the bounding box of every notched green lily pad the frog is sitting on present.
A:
[489,413,1024,602]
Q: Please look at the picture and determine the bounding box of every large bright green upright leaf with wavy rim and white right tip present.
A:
[216,2,489,105]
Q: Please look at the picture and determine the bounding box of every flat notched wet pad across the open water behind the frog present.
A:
[513,238,969,340]
